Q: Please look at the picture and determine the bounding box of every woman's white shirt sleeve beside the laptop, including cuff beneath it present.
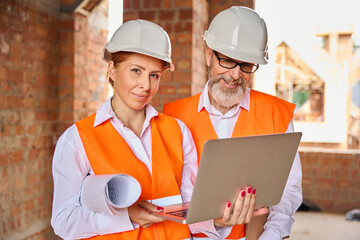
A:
[177,120,231,240]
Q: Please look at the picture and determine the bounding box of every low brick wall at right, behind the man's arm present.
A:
[300,148,360,213]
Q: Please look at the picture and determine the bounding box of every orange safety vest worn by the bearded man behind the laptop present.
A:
[163,90,295,239]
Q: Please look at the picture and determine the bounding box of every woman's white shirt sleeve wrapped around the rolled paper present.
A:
[51,125,134,240]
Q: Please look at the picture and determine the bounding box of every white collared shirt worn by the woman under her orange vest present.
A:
[51,99,228,240]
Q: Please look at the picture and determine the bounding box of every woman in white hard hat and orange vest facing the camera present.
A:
[51,20,258,239]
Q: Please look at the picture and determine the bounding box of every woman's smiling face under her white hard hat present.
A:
[108,53,164,111]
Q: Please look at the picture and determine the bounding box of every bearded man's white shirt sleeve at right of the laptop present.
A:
[259,121,302,240]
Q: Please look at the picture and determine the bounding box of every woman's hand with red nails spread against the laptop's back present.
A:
[214,187,269,227]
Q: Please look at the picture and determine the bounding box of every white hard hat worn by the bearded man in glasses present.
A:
[204,6,268,64]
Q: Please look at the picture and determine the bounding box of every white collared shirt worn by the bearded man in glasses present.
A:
[198,83,302,240]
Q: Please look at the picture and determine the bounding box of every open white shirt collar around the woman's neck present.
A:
[94,97,158,127]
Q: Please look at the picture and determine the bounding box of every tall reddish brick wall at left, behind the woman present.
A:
[0,0,107,240]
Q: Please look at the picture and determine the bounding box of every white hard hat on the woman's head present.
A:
[102,19,174,71]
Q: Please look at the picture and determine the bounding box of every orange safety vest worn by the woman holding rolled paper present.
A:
[76,114,190,240]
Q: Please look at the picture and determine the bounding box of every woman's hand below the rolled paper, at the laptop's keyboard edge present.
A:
[128,200,165,228]
